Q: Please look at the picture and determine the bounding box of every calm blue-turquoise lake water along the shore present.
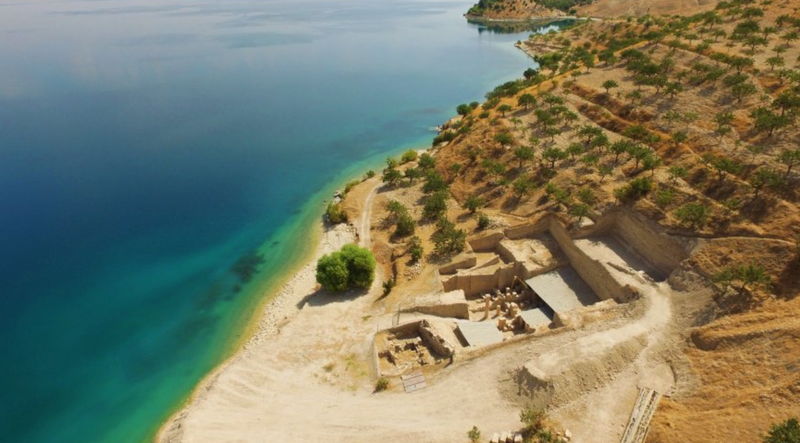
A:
[0,0,564,443]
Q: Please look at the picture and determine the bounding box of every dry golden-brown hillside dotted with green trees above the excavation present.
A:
[374,0,800,442]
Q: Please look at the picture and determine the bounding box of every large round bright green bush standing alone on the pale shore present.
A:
[316,244,376,292]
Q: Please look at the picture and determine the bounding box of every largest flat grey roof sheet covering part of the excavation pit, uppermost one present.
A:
[525,266,600,313]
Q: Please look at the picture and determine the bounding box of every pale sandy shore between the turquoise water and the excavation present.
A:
[157,179,532,443]
